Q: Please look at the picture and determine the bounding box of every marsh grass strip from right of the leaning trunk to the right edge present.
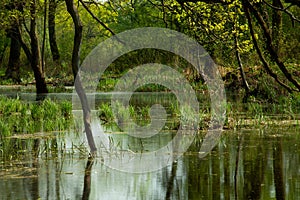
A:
[98,96,300,130]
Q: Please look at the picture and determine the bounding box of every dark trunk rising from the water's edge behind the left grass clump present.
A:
[30,0,48,99]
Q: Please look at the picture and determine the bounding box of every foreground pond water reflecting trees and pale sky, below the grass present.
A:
[0,129,300,200]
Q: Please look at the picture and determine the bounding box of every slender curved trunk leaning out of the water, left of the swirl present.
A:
[65,0,97,154]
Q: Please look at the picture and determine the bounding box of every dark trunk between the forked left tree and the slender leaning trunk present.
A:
[48,0,60,62]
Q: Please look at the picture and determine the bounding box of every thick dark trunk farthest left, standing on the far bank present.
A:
[5,23,21,83]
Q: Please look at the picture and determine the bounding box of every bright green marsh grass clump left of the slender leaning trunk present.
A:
[0,97,72,137]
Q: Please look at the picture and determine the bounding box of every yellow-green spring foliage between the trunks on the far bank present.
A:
[0,0,300,98]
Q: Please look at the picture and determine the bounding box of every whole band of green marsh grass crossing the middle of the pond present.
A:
[0,84,300,137]
